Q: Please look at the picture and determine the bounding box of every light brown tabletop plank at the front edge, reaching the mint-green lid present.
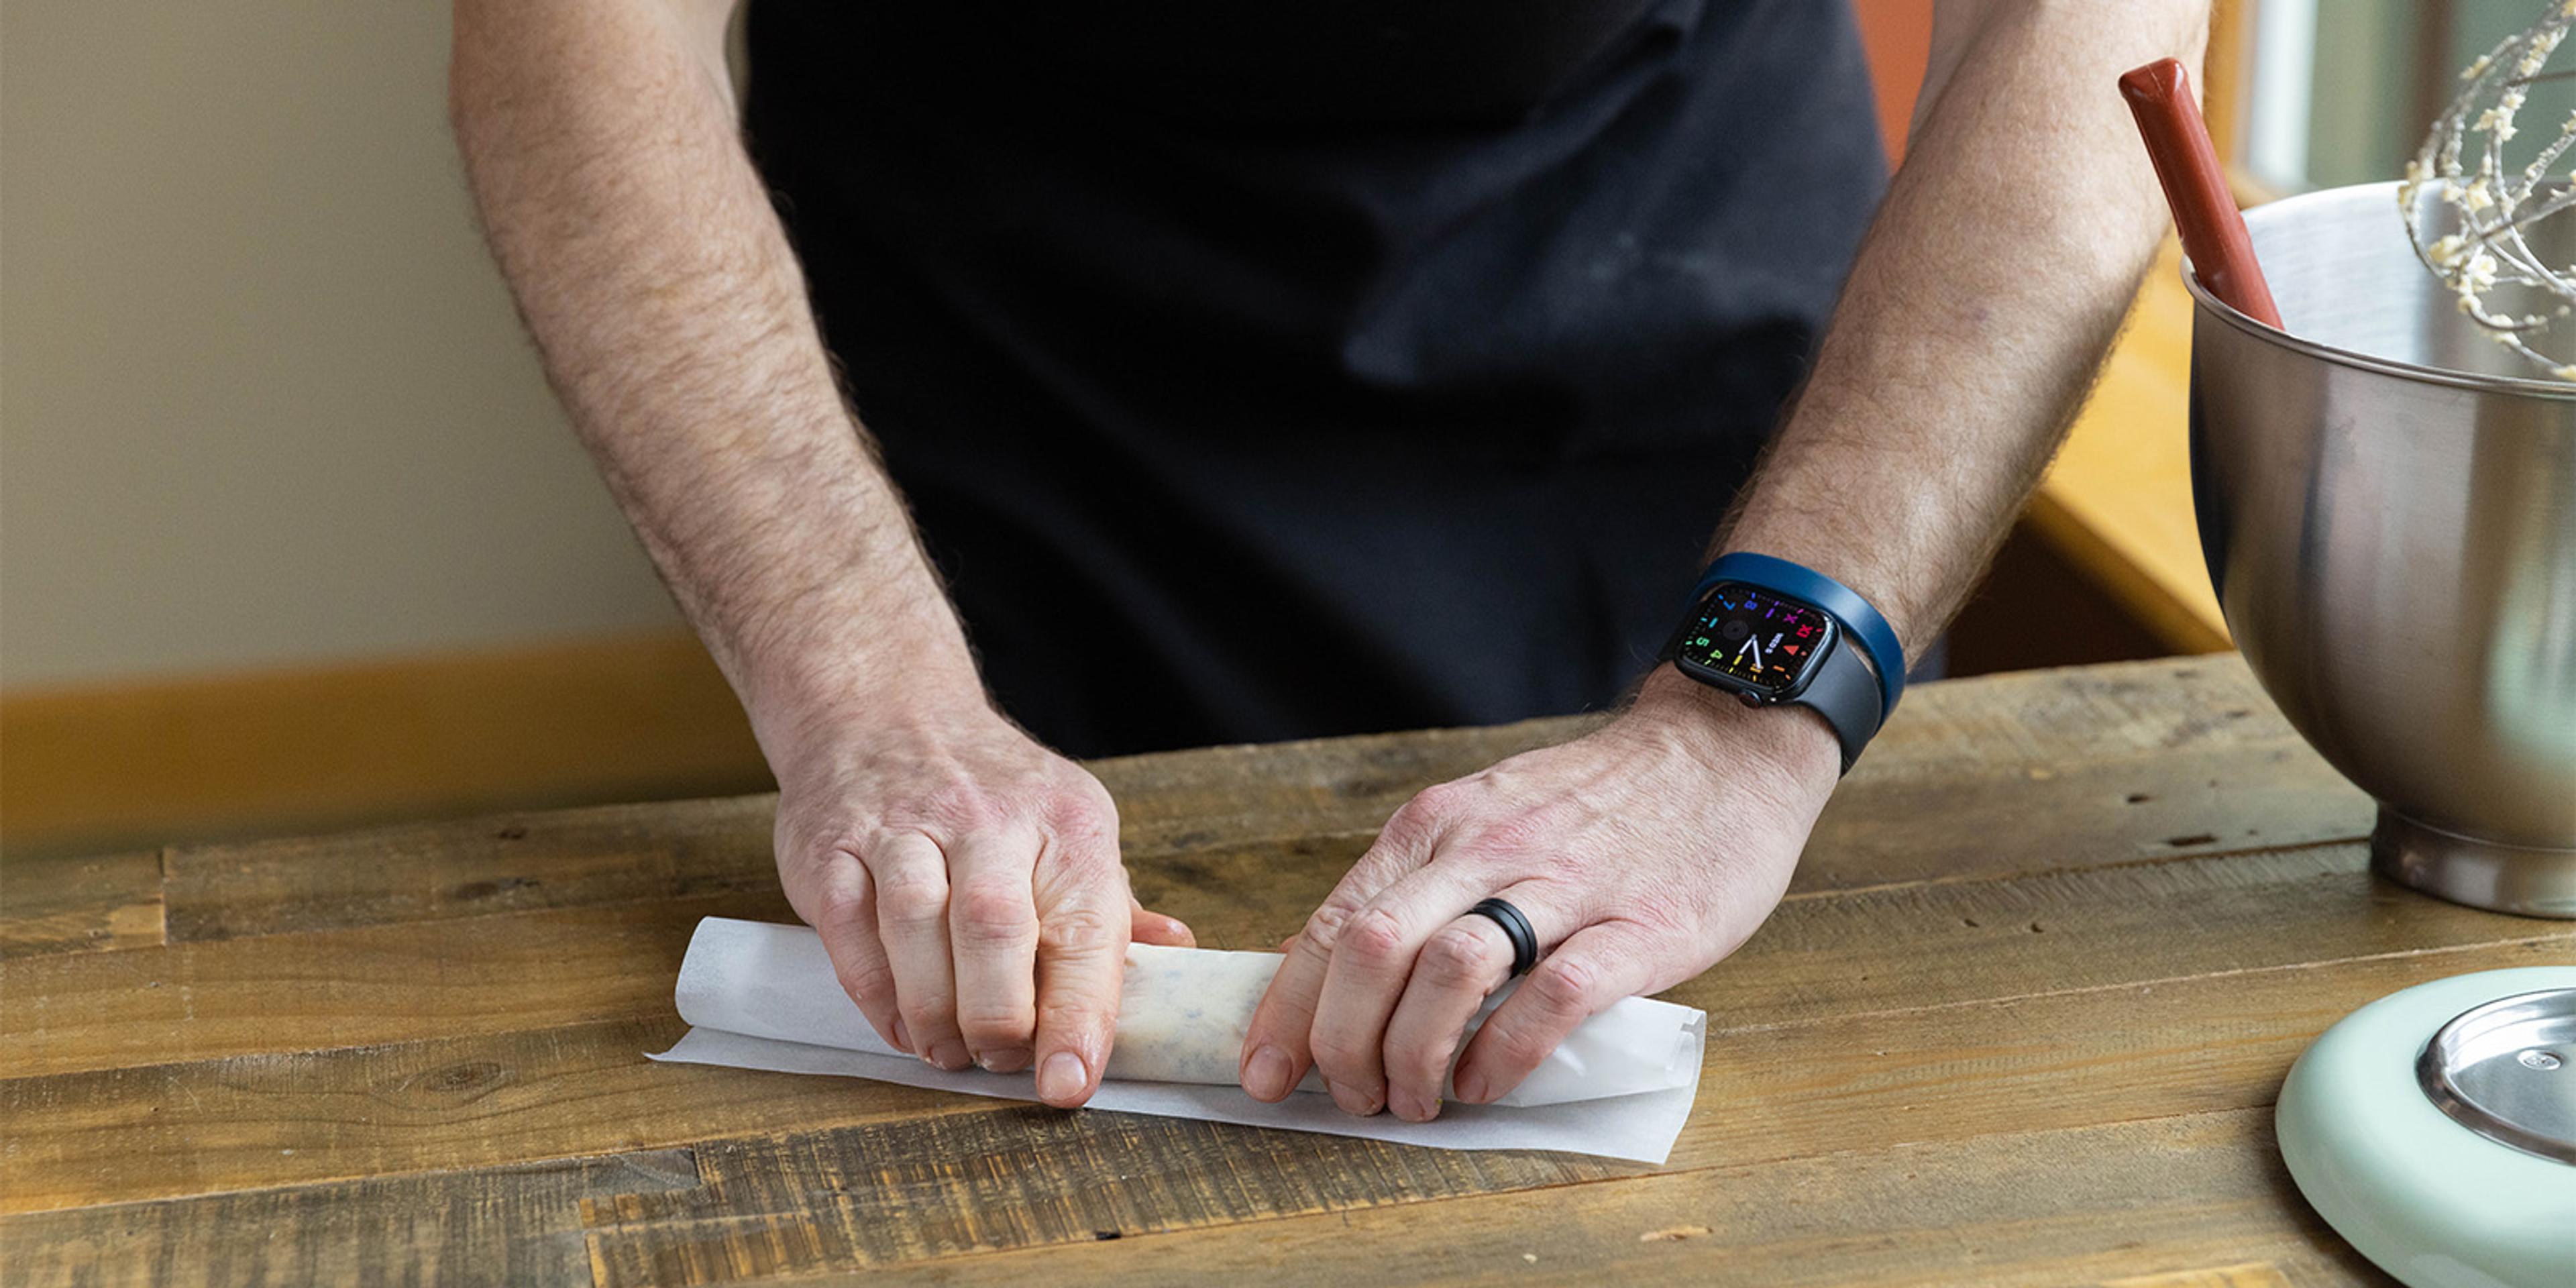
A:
[793,1110,2391,1288]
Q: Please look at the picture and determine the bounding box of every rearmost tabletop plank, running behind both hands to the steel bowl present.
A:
[125,657,2370,941]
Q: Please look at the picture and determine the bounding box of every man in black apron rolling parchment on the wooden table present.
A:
[453,0,2205,1120]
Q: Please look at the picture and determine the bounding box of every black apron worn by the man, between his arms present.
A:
[747,0,1886,755]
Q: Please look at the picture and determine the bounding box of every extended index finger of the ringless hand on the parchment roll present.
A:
[1036,837,1131,1108]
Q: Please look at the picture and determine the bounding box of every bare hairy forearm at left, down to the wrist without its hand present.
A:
[451,0,979,755]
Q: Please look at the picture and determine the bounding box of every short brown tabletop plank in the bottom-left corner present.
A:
[0,1149,700,1288]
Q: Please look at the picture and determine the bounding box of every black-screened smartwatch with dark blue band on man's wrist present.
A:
[1664,551,1907,773]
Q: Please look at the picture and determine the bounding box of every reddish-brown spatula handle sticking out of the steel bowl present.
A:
[2120,59,2288,330]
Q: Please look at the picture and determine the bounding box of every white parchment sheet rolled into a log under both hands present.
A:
[652,917,1708,1165]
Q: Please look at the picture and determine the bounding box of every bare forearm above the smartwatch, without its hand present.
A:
[1718,0,2208,652]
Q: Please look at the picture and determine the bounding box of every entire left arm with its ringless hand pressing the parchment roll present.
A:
[451,0,1187,1105]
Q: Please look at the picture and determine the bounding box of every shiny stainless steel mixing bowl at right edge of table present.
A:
[2184,183,2576,917]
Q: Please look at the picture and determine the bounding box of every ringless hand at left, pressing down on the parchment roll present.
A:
[778,706,1193,1108]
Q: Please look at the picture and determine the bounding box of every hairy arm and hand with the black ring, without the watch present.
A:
[1242,0,2208,1120]
